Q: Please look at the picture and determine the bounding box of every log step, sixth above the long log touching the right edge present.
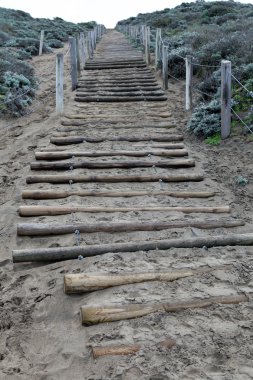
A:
[35,149,188,160]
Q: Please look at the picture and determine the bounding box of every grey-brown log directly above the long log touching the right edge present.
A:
[17,220,244,236]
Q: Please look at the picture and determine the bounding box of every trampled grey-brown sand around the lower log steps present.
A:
[0,31,253,380]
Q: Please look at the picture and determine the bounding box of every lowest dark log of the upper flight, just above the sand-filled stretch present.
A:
[75,95,167,102]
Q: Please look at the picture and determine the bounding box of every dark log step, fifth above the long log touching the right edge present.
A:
[30,159,195,170]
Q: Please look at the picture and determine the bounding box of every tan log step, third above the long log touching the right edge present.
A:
[22,190,216,199]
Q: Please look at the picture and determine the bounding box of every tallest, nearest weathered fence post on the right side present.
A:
[221,60,231,139]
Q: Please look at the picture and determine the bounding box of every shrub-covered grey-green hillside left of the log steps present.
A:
[0,8,96,116]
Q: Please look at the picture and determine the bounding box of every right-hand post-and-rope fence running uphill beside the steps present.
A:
[119,25,253,139]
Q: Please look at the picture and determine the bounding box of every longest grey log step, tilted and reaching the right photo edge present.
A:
[12,233,253,263]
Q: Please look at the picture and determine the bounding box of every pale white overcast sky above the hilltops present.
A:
[0,0,253,28]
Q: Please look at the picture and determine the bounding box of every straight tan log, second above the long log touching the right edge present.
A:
[18,206,230,216]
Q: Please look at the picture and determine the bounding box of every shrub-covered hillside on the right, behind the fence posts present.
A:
[117,1,253,137]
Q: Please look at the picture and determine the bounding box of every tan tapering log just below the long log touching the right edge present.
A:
[64,265,231,294]
